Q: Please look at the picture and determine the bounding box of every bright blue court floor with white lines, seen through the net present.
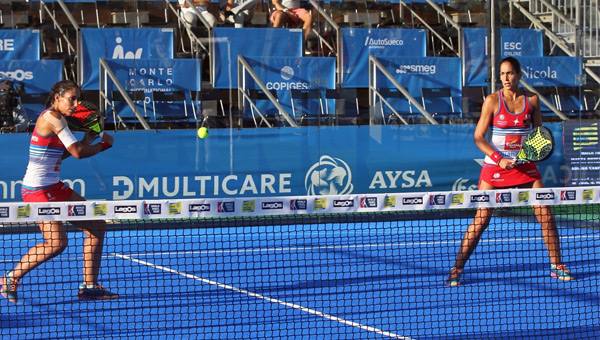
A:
[0,218,600,339]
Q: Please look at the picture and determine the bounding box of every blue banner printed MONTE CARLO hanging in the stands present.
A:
[106,59,202,121]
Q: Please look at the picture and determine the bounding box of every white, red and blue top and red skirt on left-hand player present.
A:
[21,110,73,202]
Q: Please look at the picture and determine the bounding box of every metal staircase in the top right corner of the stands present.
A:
[509,0,600,85]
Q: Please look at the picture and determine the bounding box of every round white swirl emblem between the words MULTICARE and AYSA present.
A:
[304,155,354,195]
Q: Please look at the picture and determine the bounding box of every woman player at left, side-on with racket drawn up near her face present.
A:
[0,80,118,303]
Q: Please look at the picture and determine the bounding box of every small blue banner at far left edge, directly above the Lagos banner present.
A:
[0,30,40,60]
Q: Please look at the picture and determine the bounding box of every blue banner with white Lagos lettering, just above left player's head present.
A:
[0,60,62,93]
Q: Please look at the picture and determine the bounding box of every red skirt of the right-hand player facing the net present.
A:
[479,162,542,188]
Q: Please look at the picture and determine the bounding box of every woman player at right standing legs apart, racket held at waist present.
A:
[446,57,573,286]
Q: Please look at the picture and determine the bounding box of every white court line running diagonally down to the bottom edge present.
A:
[111,253,414,340]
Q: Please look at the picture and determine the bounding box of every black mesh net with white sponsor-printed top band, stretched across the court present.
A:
[0,187,600,339]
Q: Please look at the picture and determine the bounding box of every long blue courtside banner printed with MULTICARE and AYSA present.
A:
[0,123,566,201]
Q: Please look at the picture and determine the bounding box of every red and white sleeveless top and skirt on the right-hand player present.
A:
[479,90,542,187]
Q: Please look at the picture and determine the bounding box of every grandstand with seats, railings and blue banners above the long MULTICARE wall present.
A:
[0,0,600,129]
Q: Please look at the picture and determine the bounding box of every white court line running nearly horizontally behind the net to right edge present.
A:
[118,234,600,257]
